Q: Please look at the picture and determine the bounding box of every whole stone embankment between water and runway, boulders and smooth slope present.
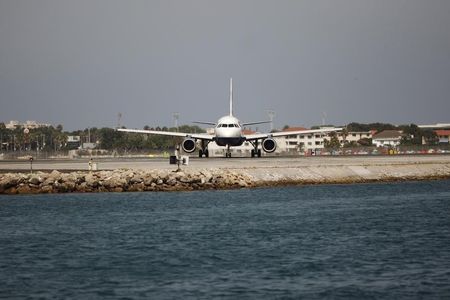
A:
[0,158,450,195]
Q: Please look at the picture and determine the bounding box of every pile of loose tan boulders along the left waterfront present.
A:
[0,169,254,194]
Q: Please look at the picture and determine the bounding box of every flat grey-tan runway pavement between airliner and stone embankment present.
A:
[0,155,450,173]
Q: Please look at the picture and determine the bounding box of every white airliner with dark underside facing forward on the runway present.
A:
[117,78,342,158]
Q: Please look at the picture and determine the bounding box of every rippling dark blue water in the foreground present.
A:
[0,180,450,299]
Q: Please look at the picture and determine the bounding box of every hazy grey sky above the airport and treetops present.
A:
[0,0,450,130]
